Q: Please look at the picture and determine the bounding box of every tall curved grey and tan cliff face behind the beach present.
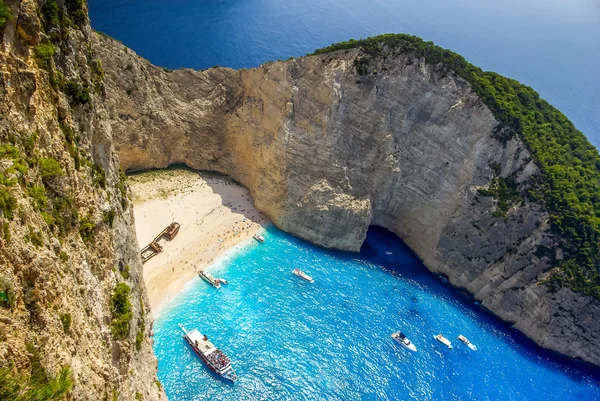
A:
[93,35,600,364]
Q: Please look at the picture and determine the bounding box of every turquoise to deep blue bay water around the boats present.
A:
[154,227,600,401]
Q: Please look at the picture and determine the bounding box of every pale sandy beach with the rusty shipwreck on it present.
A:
[128,170,269,316]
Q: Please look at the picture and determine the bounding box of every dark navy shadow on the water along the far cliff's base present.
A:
[360,226,600,383]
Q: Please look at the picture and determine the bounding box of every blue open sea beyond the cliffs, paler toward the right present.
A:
[89,0,600,147]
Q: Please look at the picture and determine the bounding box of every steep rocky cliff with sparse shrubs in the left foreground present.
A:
[0,0,166,400]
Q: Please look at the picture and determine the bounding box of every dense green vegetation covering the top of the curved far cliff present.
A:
[314,34,600,299]
